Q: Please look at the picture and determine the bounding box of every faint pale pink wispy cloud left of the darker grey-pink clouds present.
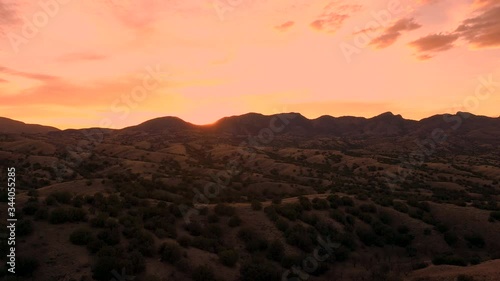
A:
[310,2,361,33]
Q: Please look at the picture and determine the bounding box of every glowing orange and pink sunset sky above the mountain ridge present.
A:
[0,0,500,129]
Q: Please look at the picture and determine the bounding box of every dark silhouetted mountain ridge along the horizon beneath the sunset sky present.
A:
[0,112,500,143]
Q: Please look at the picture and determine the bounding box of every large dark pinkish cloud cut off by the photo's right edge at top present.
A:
[455,5,500,48]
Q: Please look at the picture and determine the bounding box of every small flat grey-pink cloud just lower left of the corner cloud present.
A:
[409,33,459,60]
